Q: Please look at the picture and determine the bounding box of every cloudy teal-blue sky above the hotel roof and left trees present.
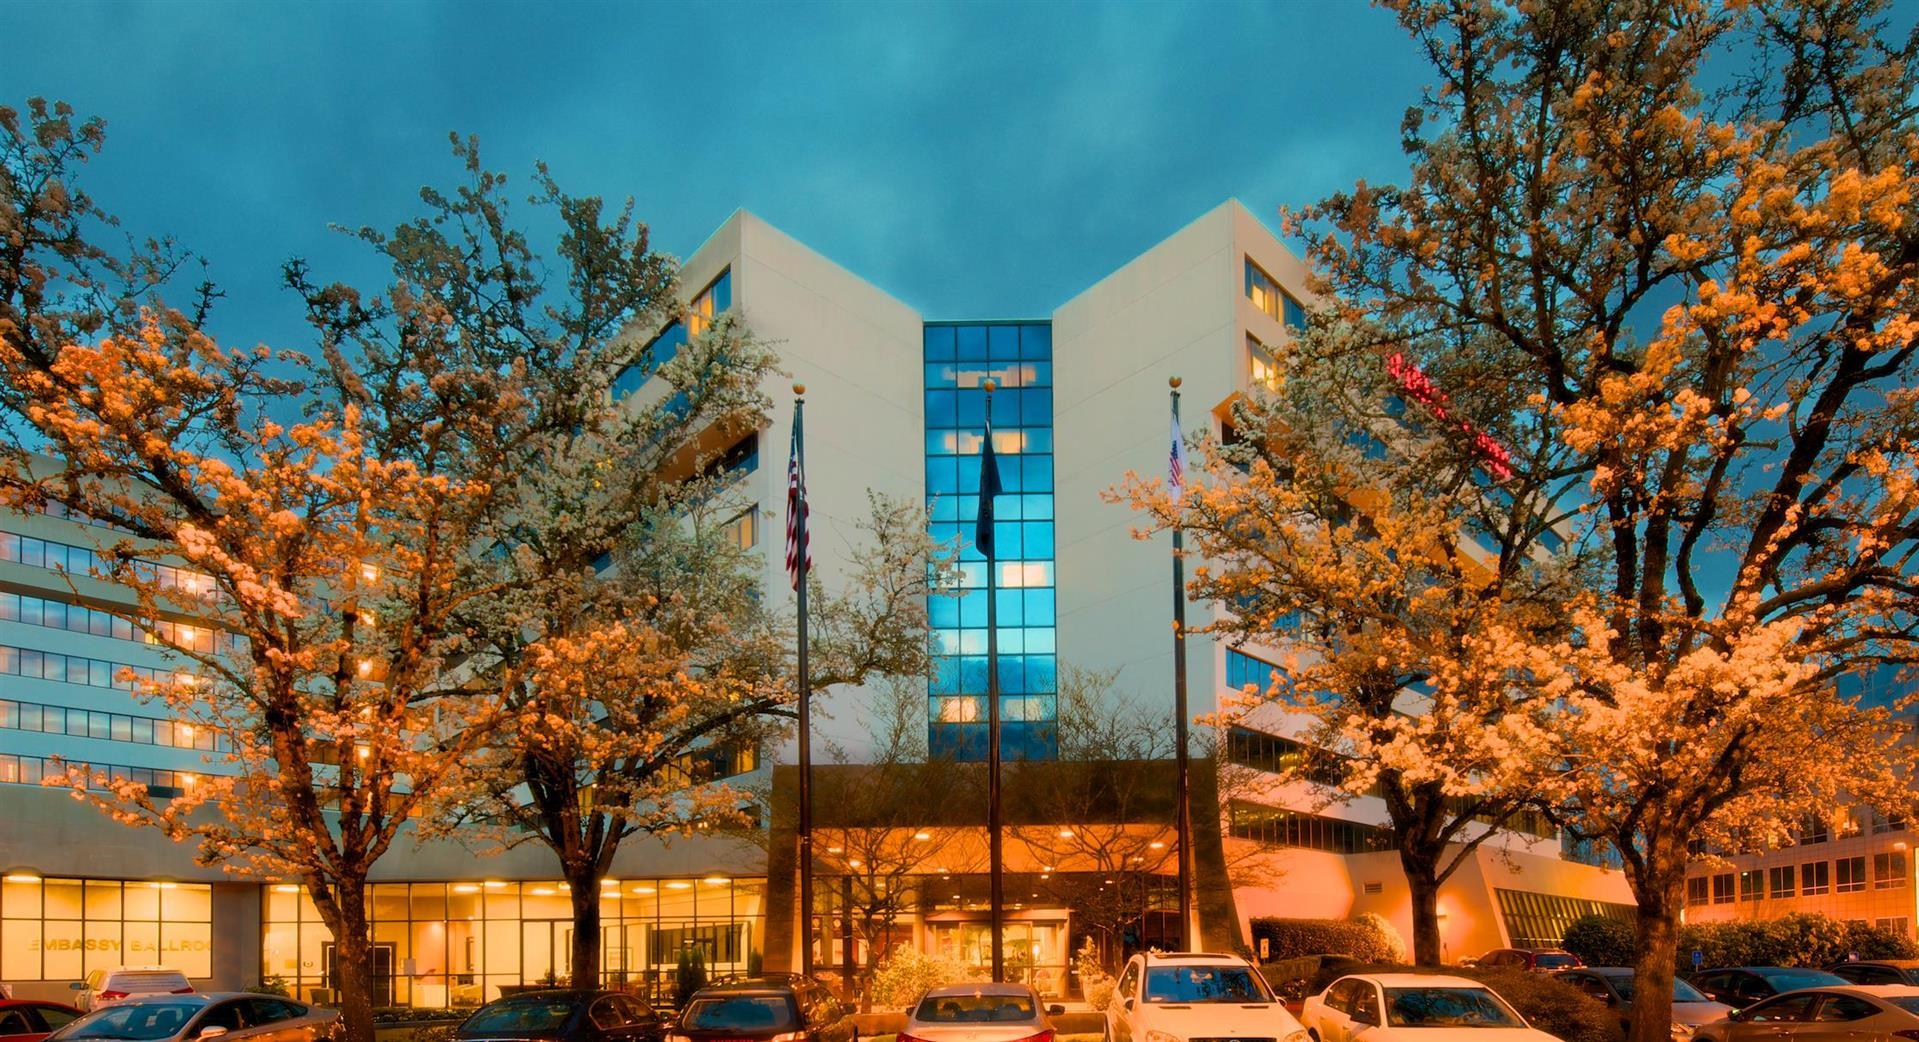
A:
[0,0,1428,345]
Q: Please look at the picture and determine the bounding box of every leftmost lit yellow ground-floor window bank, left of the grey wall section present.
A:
[0,873,213,981]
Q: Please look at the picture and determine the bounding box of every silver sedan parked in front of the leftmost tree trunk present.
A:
[46,992,340,1042]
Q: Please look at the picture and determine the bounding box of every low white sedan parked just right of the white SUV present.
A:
[1299,973,1556,1042]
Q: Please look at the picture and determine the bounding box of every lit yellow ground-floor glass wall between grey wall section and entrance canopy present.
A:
[261,877,766,1007]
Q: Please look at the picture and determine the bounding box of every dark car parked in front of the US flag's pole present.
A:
[666,975,860,1042]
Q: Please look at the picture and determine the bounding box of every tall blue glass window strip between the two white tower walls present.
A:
[925,322,1059,760]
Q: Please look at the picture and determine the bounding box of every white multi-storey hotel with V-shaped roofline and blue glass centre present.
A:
[0,201,1631,1007]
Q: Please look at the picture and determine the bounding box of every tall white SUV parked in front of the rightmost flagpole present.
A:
[1105,952,1307,1042]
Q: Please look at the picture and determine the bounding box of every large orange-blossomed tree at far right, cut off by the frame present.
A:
[1274,0,1919,1042]
